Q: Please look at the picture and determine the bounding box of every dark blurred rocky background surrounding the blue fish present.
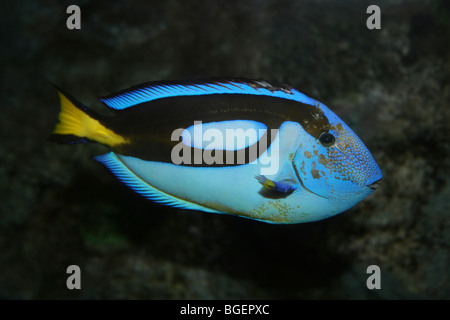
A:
[0,0,450,299]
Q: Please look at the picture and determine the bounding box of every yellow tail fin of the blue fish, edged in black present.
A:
[53,89,126,147]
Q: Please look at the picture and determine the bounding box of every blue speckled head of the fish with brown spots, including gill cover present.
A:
[293,122,381,199]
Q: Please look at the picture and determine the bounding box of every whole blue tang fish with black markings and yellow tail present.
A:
[51,78,382,224]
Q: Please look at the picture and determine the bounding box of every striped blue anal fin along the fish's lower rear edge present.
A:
[95,152,223,213]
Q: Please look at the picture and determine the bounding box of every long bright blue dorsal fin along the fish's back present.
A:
[100,78,318,110]
